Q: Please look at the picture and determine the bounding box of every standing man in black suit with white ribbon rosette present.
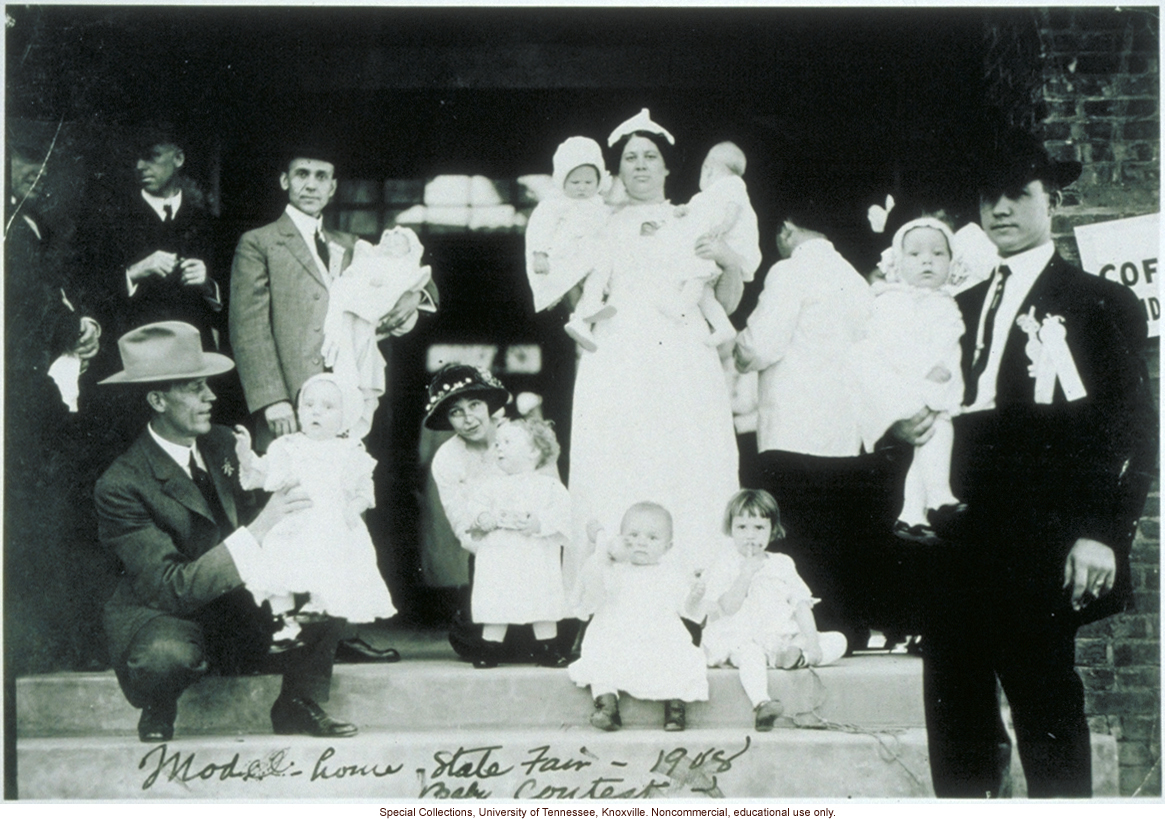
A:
[896,132,1157,797]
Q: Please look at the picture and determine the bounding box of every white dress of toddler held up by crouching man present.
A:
[239,433,396,623]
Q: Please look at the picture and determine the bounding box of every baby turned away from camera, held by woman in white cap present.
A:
[676,142,761,347]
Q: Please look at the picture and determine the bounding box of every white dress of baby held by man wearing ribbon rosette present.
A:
[854,282,963,450]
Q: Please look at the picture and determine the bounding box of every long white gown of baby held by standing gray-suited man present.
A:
[324,228,431,439]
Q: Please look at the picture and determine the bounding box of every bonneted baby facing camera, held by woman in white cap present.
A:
[525,136,615,352]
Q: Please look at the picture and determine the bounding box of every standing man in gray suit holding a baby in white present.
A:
[230,149,437,450]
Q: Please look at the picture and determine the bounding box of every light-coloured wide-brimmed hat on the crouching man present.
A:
[98,321,234,384]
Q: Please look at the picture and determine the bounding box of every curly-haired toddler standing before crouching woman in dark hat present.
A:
[461,418,571,669]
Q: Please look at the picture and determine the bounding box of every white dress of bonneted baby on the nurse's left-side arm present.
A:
[525,195,610,312]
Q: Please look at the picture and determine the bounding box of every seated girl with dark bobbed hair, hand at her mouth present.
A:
[702,489,846,731]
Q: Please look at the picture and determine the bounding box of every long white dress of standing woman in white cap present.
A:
[564,203,739,584]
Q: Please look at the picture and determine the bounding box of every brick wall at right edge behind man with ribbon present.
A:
[984,8,1162,796]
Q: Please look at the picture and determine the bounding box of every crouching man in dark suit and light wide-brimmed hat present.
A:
[96,321,356,742]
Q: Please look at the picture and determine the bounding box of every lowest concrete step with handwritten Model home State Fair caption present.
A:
[17,727,932,805]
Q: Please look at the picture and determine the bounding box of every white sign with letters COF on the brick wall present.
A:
[1075,213,1162,337]
